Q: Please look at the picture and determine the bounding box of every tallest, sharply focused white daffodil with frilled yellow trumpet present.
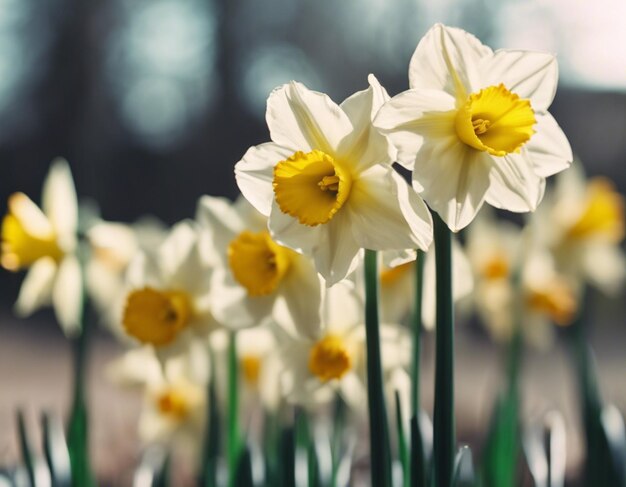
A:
[374,24,572,231]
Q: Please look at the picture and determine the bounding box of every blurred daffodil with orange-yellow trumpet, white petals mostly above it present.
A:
[119,221,217,359]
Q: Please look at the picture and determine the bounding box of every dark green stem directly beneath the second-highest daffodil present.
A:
[365,250,391,487]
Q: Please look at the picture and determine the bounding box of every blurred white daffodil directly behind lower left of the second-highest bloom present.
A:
[196,196,322,333]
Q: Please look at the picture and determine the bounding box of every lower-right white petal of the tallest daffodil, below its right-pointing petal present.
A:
[486,151,546,212]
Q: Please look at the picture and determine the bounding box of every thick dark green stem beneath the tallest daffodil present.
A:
[433,213,456,487]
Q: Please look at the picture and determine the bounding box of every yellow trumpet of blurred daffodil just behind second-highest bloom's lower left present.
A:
[228,231,294,296]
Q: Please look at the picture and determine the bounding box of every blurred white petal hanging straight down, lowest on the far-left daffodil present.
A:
[52,255,83,336]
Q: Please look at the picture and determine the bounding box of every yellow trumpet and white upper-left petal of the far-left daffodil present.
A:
[0,193,63,271]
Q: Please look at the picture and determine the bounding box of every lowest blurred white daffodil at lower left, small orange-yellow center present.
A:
[106,342,209,465]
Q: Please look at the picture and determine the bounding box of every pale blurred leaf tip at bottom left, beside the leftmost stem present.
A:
[42,414,72,487]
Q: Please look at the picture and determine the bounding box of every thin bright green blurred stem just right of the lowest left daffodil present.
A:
[226,332,240,487]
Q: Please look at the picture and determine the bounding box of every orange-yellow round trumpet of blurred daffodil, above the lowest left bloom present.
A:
[122,287,192,346]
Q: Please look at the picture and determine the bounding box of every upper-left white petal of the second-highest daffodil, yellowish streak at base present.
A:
[265,81,352,154]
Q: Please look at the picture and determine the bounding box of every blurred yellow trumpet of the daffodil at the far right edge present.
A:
[567,178,624,242]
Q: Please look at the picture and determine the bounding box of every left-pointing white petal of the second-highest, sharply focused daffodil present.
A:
[235,142,294,216]
